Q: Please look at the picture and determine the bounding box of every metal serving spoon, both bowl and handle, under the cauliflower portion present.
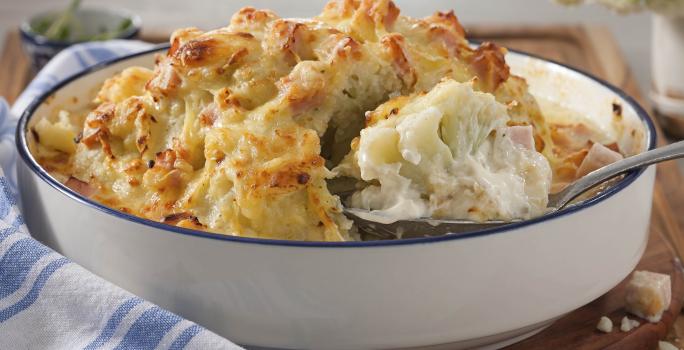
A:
[344,141,684,239]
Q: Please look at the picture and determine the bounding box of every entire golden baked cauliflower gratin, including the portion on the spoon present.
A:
[31,0,640,241]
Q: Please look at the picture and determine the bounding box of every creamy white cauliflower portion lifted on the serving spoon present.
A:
[338,80,551,220]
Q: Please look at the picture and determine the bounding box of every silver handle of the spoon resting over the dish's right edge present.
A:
[549,141,684,209]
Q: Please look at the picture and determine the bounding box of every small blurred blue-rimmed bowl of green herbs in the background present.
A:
[20,3,142,70]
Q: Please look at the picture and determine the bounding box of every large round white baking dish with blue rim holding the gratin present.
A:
[16,49,655,349]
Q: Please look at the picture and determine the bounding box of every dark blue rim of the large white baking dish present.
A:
[15,44,656,248]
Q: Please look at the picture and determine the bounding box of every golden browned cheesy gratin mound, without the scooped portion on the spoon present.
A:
[34,0,576,241]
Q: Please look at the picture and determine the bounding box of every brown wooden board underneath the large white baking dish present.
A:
[0,26,684,350]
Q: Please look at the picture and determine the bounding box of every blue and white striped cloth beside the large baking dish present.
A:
[0,41,240,349]
